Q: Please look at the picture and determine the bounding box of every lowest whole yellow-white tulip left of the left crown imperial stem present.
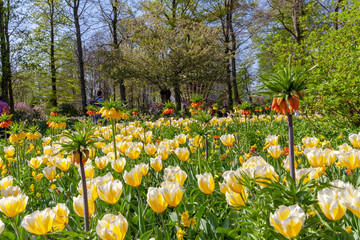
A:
[21,208,56,235]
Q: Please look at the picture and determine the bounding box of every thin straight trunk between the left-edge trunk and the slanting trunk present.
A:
[49,0,57,107]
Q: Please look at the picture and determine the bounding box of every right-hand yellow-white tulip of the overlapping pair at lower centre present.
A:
[161,181,184,207]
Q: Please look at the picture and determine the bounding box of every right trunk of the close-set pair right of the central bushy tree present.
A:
[229,0,239,101]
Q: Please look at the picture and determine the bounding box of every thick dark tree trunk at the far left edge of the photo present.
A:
[0,0,14,109]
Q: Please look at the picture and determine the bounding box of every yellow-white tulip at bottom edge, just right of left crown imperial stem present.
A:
[96,214,128,240]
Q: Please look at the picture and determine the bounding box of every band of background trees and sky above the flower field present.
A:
[0,0,360,126]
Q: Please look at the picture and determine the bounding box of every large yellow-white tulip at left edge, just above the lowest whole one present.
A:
[0,194,29,217]
